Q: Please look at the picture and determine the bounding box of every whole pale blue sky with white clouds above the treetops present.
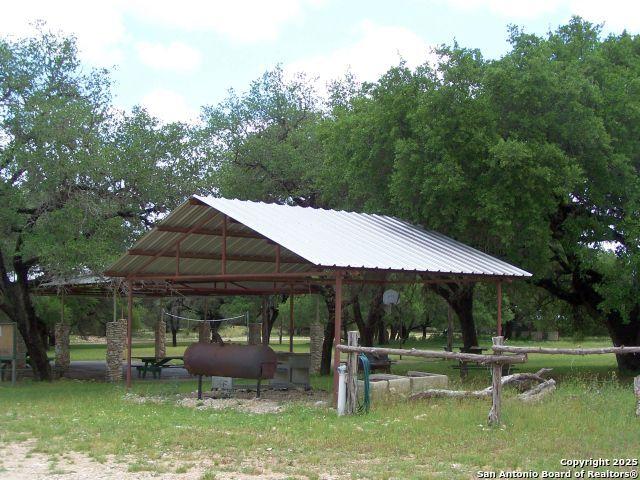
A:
[0,0,640,122]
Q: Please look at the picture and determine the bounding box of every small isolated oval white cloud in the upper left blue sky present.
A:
[136,42,202,72]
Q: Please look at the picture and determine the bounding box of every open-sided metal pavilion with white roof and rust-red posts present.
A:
[105,195,531,389]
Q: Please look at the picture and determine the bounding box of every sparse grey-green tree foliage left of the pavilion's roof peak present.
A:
[0,28,206,275]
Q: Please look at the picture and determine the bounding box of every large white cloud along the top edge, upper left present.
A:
[0,0,324,66]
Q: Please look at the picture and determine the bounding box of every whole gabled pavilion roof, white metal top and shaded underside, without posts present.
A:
[108,196,530,277]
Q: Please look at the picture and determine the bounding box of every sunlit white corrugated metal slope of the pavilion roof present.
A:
[194,196,531,277]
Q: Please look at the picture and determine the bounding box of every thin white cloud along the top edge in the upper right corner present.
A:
[439,0,640,32]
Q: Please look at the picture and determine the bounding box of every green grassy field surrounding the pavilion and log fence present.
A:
[0,339,640,479]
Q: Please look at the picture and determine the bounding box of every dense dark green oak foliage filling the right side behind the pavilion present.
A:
[319,18,640,341]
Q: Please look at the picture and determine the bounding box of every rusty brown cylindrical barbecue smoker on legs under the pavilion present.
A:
[184,342,278,399]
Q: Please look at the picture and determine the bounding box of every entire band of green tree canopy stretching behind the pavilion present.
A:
[0,18,640,378]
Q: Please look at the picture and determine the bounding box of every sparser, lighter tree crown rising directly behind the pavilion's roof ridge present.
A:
[201,67,320,205]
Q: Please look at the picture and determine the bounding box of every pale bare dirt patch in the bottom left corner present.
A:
[0,441,291,480]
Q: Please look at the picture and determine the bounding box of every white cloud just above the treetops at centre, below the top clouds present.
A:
[286,20,435,84]
